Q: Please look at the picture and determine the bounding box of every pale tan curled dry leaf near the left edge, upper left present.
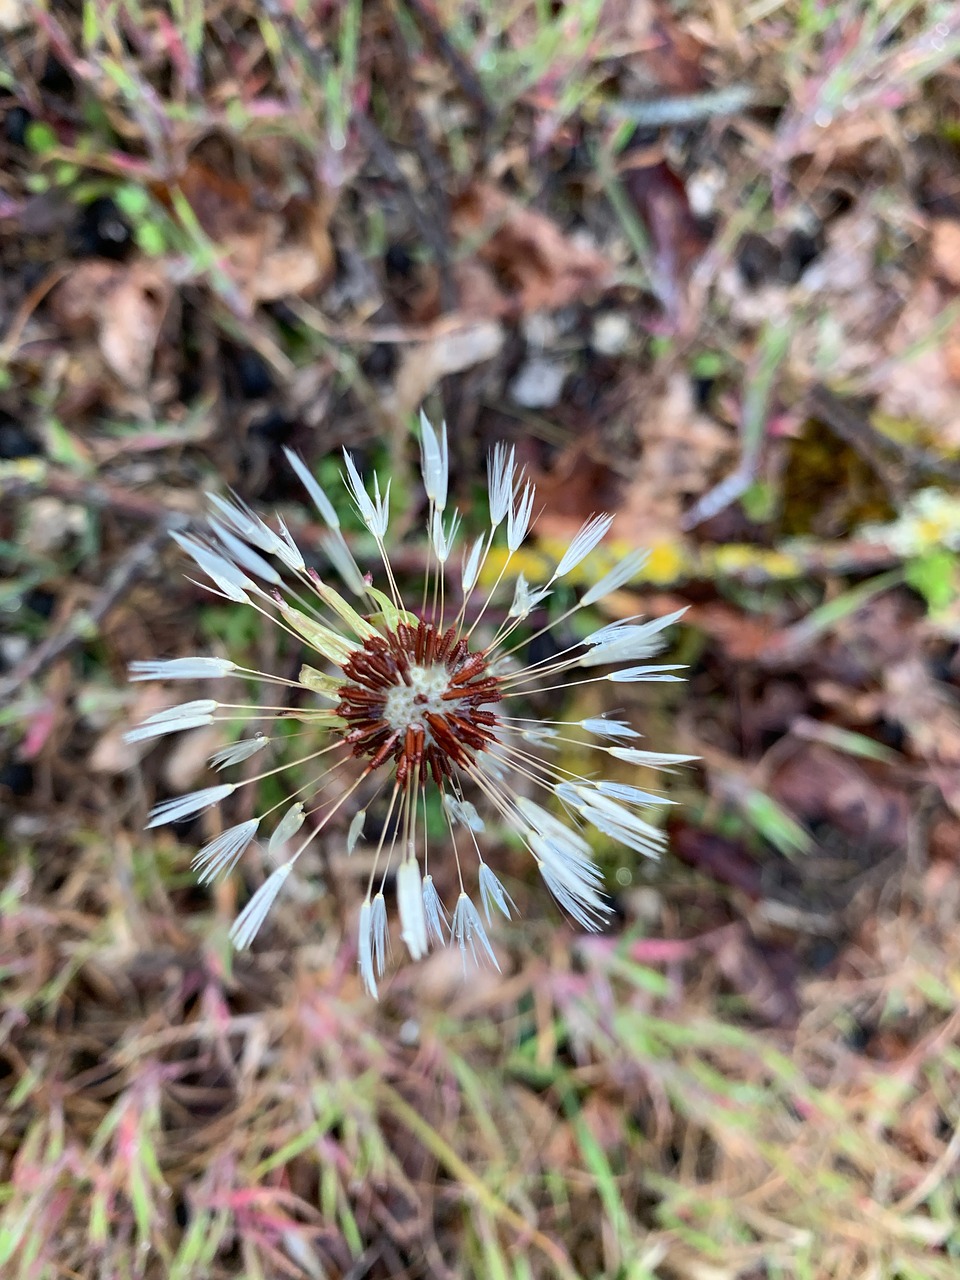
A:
[51,260,170,390]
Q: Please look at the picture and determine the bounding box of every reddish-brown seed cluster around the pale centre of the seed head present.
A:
[337,621,502,786]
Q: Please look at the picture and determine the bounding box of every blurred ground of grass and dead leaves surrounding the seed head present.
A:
[0,0,960,1280]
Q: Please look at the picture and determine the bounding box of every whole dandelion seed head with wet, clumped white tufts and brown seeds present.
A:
[128,416,691,995]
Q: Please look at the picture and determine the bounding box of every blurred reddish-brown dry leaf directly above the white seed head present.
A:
[451,183,613,315]
